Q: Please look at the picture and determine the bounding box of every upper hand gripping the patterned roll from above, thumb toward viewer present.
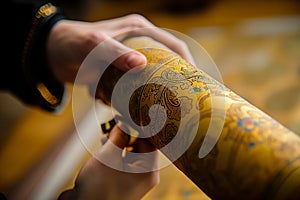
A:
[47,14,193,87]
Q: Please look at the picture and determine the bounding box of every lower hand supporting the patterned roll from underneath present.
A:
[58,126,159,200]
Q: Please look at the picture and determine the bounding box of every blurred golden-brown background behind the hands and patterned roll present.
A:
[0,0,300,200]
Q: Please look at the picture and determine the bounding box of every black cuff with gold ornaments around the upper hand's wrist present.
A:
[22,3,64,111]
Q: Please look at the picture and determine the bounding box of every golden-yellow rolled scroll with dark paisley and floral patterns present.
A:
[100,37,300,200]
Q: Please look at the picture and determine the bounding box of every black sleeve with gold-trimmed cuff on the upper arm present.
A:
[0,0,65,111]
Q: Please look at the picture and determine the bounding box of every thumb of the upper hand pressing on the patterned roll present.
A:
[96,38,147,71]
